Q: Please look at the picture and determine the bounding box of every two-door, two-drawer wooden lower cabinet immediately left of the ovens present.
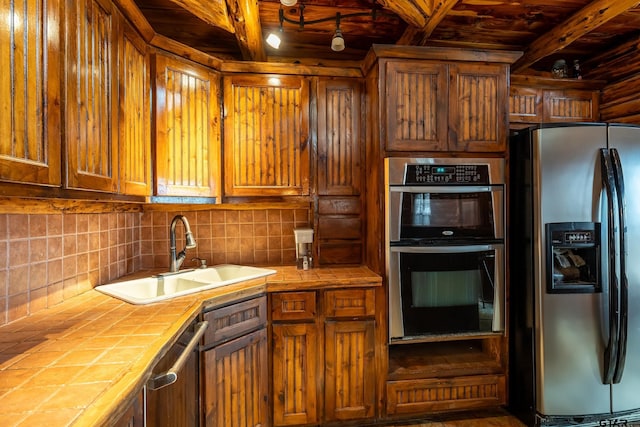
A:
[271,288,377,426]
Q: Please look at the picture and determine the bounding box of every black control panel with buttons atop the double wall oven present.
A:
[404,164,489,185]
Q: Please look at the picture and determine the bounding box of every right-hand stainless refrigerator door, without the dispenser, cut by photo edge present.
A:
[609,126,640,412]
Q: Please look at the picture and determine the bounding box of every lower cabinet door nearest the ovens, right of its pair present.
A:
[325,320,376,421]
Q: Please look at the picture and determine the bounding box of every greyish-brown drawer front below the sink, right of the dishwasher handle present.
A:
[204,296,267,346]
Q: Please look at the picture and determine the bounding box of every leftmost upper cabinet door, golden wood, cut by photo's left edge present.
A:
[0,0,61,186]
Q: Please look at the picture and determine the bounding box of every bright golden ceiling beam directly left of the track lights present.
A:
[226,0,267,61]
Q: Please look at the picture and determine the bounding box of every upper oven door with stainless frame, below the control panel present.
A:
[388,184,504,242]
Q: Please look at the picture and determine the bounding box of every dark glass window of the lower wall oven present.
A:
[400,250,495,335]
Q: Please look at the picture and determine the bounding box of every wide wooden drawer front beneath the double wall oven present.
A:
[387,375,506,415]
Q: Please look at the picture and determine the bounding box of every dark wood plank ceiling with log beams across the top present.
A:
[134,0,640,78]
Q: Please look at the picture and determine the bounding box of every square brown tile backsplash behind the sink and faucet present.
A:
[0,209,310,325]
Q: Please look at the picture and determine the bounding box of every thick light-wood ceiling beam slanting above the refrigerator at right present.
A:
[511,0,640,73]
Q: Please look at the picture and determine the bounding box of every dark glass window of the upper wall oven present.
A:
[400,192,494,239]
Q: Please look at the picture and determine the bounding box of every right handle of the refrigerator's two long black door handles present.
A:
[609,148,629,384]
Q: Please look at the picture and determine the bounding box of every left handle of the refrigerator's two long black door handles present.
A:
[600,148,620,384]
